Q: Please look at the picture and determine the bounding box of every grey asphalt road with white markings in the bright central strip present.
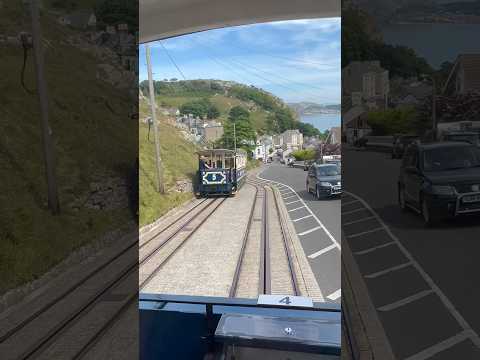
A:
[259,162,341,302]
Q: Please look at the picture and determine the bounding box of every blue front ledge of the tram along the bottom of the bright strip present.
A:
[139,293,341,360]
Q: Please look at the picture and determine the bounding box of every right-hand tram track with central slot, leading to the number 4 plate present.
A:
[229,180,300,297]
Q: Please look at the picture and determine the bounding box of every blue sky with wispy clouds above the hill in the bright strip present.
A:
[139,18,341,103]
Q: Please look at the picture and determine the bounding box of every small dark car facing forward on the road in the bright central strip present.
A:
[306,164,342,200]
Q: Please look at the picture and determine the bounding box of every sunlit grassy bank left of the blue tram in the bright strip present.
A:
[139,101,197,226]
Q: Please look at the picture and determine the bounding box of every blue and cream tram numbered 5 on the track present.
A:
[195,149,247,197]
